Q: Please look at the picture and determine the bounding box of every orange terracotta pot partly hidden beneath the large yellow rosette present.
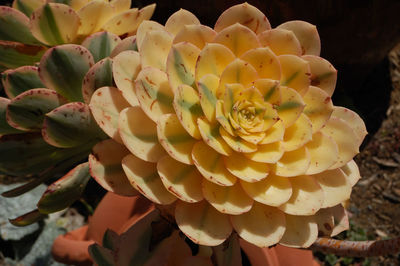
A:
[52,193,319,266]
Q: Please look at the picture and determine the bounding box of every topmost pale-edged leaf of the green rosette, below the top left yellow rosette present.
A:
[82,31,121,62]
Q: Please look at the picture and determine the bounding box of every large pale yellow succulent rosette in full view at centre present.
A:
[89,3,366,247]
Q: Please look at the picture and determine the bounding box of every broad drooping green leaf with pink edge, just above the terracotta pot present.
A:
[37,163,90,213]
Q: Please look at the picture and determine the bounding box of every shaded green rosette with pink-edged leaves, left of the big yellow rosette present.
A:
[0,29,142,226]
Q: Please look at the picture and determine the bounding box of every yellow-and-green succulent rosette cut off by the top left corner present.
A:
[0,0,155,71]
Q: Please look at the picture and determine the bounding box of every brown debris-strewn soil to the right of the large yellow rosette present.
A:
[349,44,400,265]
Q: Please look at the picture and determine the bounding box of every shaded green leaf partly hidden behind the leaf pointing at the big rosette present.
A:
[7,89,66,131]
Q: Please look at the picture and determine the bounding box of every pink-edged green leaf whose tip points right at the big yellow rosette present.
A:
[42,102,105,148]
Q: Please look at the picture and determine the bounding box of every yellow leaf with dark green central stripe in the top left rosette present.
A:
[30,3,80,45]
